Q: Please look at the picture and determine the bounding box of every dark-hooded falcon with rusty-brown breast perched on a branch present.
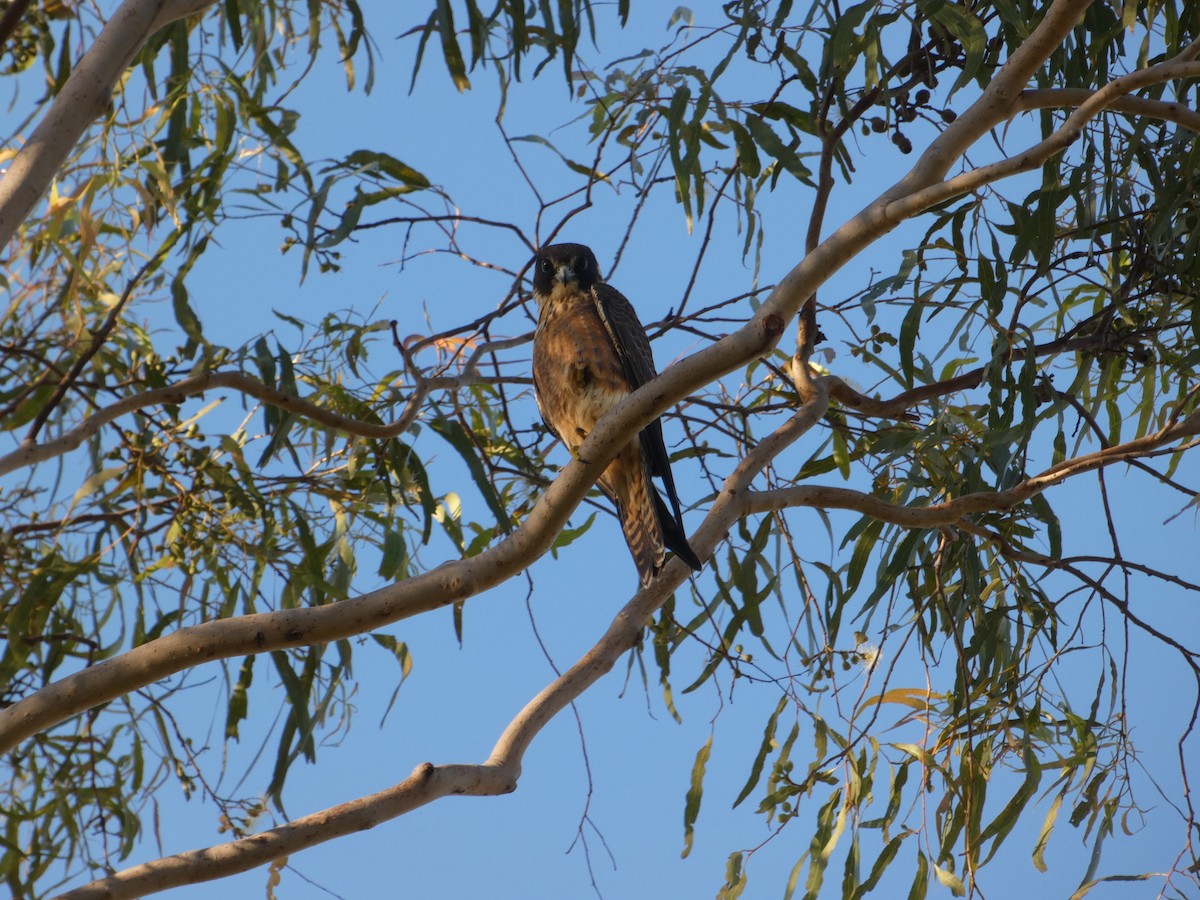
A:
[533,244,701,587]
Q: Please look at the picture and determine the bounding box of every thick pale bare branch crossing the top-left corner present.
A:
[0,0,216,248]
